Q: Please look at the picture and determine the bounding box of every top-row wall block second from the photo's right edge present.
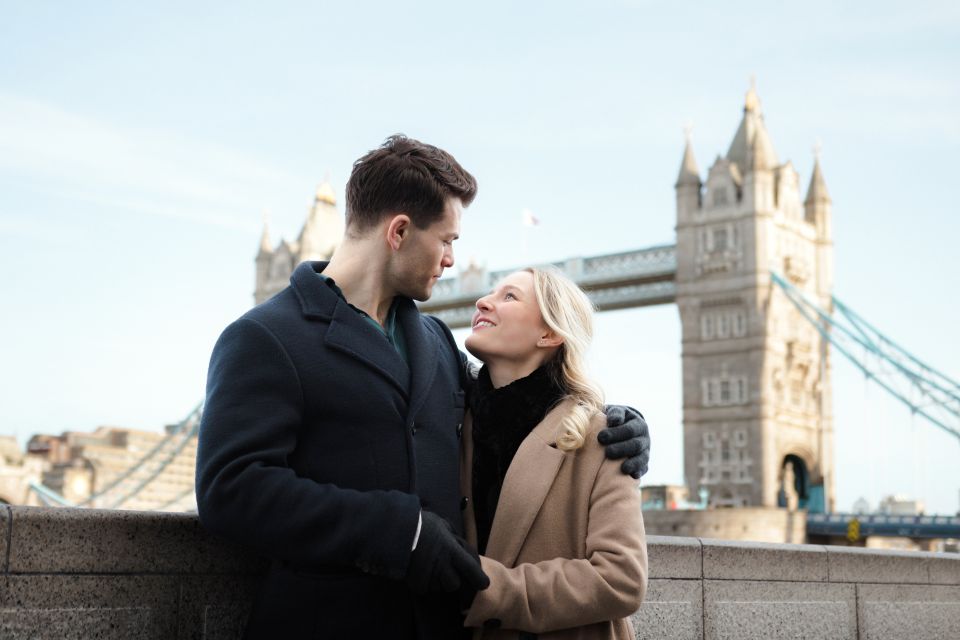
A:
[826,546,931,584]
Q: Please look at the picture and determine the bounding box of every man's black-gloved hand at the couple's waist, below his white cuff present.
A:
[405,511,490,595]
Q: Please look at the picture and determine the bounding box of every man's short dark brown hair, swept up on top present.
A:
[346,134,477,231]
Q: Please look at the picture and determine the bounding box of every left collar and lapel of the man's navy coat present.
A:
[290,262,413,396]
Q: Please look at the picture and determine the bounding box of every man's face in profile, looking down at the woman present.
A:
[394,198,463,301]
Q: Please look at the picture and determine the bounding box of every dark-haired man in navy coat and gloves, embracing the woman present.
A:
[197,136,649,638]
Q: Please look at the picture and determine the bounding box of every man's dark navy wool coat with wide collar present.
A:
[197,262,464,638]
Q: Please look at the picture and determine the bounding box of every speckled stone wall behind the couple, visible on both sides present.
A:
[0,506,960,640]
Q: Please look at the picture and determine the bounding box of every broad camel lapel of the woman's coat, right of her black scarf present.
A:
[487,400,571,567]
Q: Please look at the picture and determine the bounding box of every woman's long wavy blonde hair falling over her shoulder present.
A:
[525,267,603,451]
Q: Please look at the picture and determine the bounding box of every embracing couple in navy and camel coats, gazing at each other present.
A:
[197,136,649,639]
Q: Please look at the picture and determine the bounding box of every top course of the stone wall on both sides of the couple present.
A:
[0,506,960,585]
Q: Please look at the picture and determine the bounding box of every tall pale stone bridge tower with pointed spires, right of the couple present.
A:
[676,87,834,510]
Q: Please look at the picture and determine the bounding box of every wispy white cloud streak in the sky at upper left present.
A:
[0,94,309,229]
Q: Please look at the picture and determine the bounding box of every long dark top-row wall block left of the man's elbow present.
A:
[9,507,266,573]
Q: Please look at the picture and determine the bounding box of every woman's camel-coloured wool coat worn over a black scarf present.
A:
[460,400,647,640]
